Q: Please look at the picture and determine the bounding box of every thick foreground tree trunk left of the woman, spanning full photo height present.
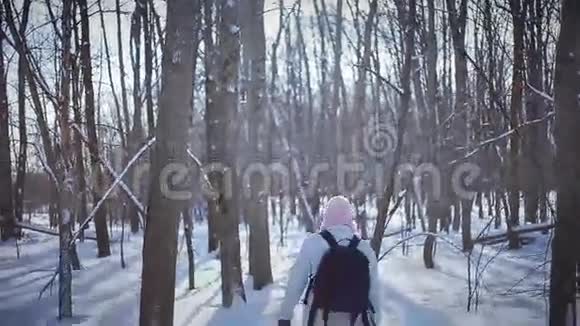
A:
[139,0,195,326]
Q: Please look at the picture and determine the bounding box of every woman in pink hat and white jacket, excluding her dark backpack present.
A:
[279,196,380,326]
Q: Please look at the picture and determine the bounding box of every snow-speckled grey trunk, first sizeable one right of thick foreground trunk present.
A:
[212,0,245,307]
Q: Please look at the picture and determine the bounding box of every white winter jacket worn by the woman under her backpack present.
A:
[279,225,380,326]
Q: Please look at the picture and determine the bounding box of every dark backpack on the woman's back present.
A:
[305,230,371,326]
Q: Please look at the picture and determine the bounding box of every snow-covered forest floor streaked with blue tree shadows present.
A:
[0,208,550,326]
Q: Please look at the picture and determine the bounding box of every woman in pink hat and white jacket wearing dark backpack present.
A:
[278,196,380,326]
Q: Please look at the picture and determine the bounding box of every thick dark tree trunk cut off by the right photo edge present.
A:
[550,0,580,326]
